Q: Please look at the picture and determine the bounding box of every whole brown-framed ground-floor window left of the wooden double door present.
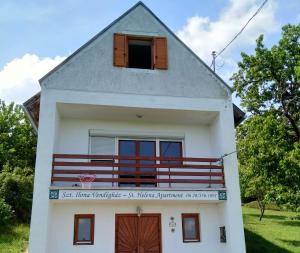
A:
[73,214,95,245]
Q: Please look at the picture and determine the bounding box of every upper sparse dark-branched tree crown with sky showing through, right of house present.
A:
[232,24,300,142]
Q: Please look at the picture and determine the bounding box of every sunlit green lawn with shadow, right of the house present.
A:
[243,207,300,253]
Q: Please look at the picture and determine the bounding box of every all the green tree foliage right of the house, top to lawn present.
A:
[232,24,300,217]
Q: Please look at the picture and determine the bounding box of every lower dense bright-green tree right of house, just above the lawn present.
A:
[237,111,300,220]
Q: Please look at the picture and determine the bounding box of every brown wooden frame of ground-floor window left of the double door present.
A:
[73,214,95,245]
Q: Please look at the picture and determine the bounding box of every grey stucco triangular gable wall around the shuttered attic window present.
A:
[41,5,230,98]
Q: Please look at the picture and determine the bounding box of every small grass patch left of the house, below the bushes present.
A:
[0,224,29,253]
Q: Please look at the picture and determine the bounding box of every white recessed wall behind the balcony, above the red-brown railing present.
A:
[55,118,215,157]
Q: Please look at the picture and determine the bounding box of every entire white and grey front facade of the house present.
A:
[25,3,245,253]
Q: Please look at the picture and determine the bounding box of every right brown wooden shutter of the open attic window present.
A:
[154,37,168,69]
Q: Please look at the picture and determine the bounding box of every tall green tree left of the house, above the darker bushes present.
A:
[0,100,36,171]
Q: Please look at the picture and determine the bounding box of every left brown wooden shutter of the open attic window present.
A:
[114,33,127,67]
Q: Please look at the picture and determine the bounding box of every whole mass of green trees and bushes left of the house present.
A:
[0,100,36,222]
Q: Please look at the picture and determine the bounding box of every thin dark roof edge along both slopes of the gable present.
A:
[39,1,233,92]
